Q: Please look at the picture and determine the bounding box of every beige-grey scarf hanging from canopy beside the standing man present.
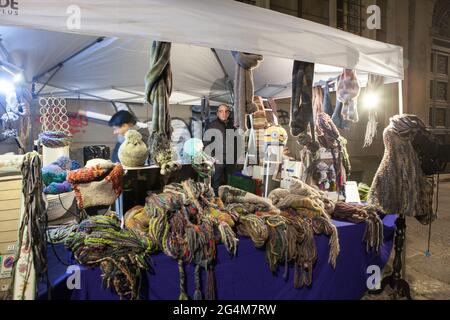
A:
[231,51,263,132]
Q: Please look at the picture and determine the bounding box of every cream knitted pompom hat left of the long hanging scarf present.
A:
[119,130,148,167]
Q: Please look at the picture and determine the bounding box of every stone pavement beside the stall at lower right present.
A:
[363,179,450,300]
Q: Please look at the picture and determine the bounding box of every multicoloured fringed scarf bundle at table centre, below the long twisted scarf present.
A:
[144,180,238,300]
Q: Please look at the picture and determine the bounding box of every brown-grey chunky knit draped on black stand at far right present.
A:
[368,114,436,224]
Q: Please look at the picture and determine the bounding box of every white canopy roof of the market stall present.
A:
[0,0,403,104]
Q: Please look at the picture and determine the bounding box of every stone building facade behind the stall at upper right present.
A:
[240,0,450,183]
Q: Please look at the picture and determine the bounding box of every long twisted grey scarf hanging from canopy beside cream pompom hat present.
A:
[145,41,180,175]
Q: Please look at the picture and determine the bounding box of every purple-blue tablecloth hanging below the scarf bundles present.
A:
[40,215,396,300]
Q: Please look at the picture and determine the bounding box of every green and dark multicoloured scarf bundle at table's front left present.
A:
[65,216,157,299]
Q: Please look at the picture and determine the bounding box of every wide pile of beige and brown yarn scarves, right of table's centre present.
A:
[219,180,339,288]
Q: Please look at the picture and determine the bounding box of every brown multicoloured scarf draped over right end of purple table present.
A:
[332,202,384,253]
